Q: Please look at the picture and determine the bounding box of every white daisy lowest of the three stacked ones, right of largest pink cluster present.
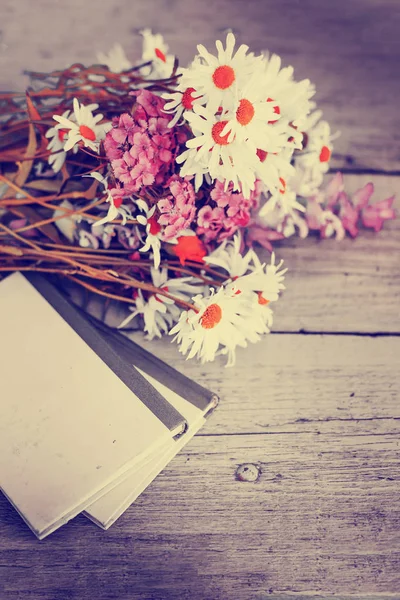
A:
[178,105,259,196]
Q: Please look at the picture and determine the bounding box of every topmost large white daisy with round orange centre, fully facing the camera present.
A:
[183,33,261,113]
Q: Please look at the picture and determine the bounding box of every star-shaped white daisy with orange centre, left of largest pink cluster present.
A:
[53,98,112,152]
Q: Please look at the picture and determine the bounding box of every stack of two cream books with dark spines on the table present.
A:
[0,273,218,539]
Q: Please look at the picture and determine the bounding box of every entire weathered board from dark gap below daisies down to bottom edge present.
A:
[0,334,400,600]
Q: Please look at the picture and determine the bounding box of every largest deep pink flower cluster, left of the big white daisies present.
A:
[104,90,186,196]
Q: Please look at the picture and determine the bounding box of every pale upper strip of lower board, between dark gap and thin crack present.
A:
[124,334,400,436]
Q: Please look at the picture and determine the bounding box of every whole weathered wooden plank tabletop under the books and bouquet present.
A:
[0,0,400,600]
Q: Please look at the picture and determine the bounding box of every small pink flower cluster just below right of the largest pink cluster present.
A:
[157,175,196,240]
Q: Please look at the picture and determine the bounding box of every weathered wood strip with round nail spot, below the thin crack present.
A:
[0,428,400,600]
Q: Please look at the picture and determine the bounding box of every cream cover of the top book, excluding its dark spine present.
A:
[0,273,170,537]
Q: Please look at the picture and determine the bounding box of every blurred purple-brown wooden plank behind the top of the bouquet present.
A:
[0,0,400,171]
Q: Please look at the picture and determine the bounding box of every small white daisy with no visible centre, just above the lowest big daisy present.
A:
[204,233,255,278]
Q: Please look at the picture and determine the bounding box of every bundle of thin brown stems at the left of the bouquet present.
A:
[0,64,226,309]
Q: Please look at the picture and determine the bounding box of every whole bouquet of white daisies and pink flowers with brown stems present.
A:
[0,30,395,365]
